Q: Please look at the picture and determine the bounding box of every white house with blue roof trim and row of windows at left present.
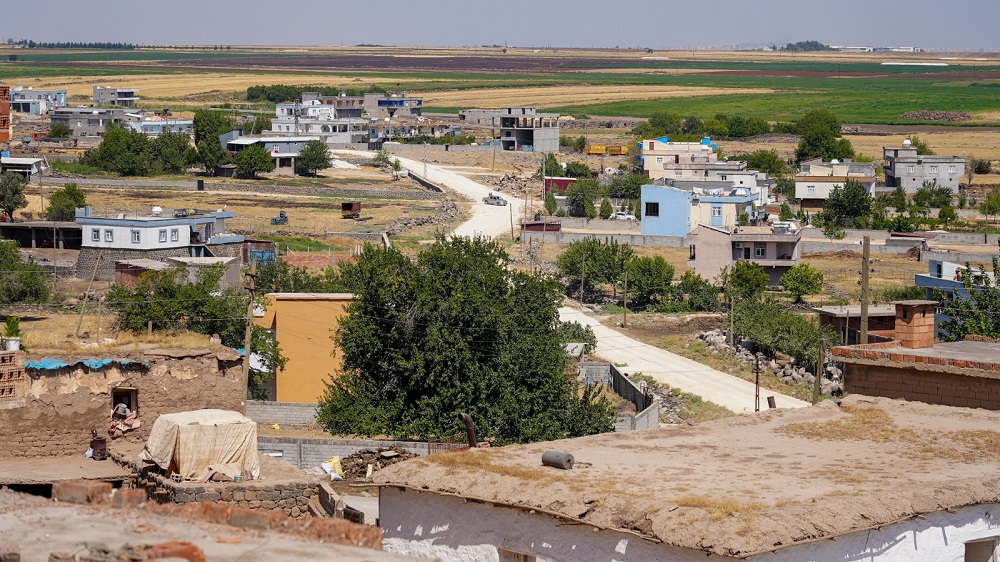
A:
[76,207,243,281]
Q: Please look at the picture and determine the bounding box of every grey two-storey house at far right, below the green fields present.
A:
[882,139,965,193]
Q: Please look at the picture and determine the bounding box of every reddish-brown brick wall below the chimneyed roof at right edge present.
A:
[844,363,1000,410]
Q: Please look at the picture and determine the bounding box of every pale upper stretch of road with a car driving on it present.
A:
[396,156,524,238]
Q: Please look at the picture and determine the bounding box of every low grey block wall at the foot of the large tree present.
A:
[257,436,467,469]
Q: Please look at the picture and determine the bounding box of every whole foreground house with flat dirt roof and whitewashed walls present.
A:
[374,392,1000,562]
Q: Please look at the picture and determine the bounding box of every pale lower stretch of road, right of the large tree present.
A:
[559,306,809,413]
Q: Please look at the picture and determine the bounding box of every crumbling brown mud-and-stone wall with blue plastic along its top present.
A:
[0,349,243,458]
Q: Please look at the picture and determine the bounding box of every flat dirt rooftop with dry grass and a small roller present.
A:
[374,395,1000,557]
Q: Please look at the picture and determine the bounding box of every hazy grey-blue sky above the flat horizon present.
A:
[7,0,1000,51]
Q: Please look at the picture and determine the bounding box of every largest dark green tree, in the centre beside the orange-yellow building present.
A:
[318,236,614,444]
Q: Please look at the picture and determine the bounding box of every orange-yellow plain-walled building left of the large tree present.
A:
[254,293,354,403]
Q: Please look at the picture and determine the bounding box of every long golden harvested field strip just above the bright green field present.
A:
[423,85,774,107]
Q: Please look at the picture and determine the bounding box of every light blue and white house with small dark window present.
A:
[640,180,760,237]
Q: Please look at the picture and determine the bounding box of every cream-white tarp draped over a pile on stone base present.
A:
[139,410,260,479]
